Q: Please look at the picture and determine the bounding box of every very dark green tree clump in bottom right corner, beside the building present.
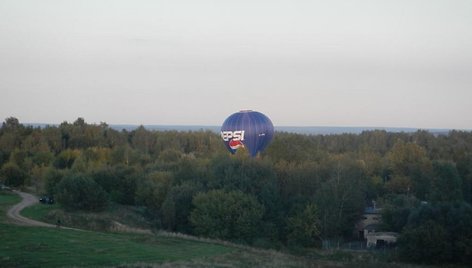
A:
[398,202,472,264]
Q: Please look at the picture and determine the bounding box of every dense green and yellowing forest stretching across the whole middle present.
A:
[0,117,472,264]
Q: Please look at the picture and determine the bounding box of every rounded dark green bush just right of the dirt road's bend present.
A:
[56,174,108,211]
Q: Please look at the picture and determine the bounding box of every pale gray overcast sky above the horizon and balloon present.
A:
[0,0,472,129]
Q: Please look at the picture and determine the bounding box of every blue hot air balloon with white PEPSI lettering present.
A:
[221,110,274,157]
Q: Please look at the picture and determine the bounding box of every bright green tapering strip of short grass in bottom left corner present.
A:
[0,224,235,267]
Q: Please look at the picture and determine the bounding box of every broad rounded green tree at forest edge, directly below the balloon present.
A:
[190,190,264,242]
